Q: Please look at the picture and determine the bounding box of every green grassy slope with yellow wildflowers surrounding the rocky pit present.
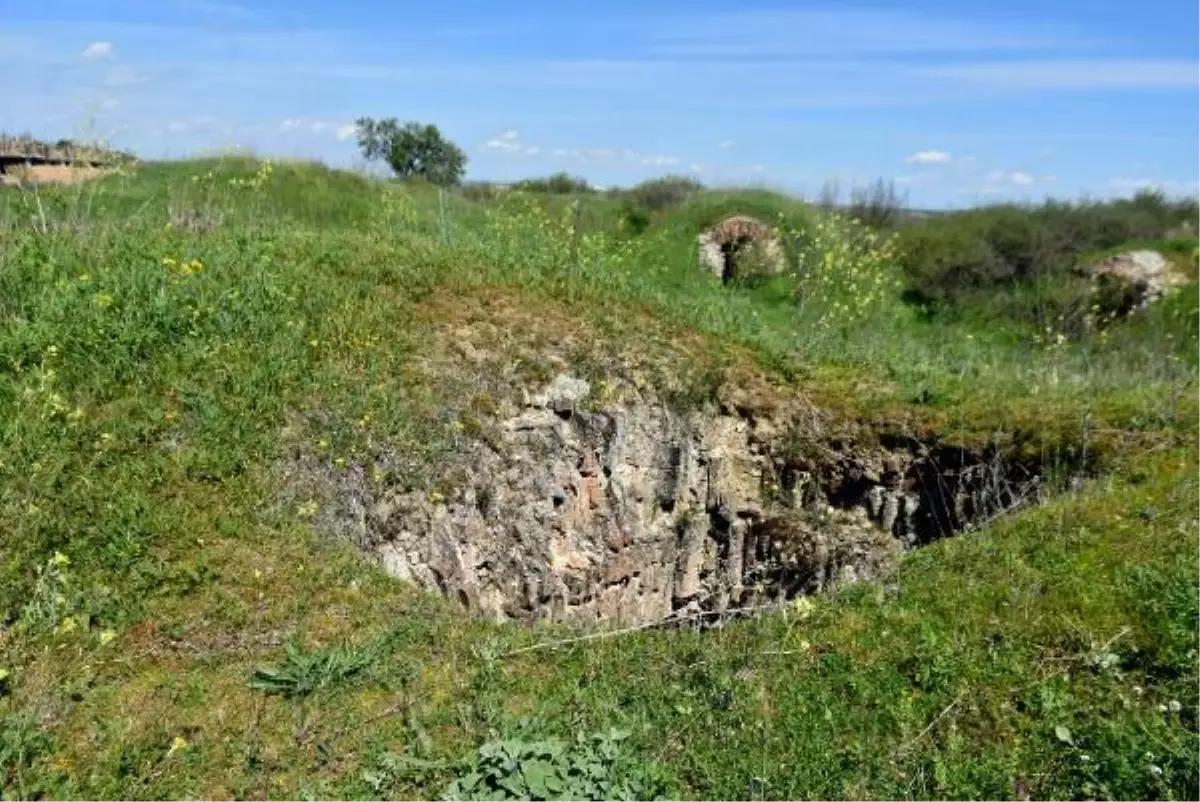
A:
[0,162,1200,800]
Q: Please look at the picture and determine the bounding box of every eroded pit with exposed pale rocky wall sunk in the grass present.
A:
[297,375,1080,626]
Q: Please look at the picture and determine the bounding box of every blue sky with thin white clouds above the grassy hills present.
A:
[0,0,1200,207]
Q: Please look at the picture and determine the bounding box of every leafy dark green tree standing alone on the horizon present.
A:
[356,116,467,186]
